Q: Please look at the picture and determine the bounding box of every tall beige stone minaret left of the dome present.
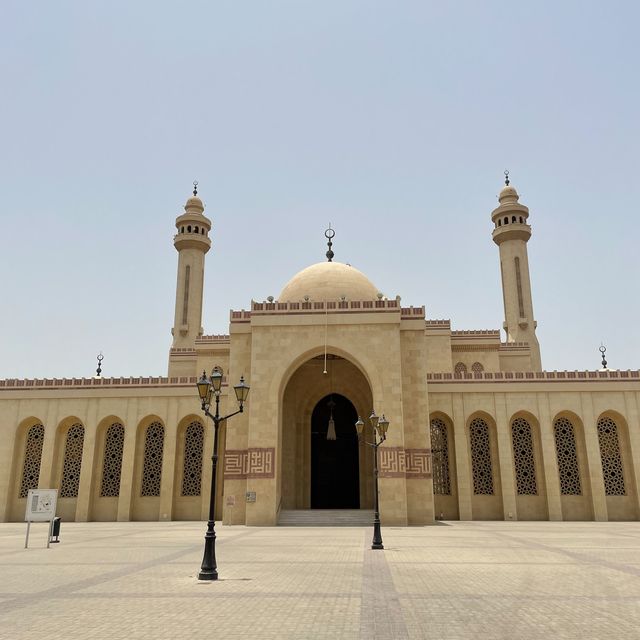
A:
[169,181,211,376]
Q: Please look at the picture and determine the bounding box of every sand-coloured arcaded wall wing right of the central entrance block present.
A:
[429,376,640,520]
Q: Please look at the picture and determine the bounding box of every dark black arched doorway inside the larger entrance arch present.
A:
[311,393,360,509]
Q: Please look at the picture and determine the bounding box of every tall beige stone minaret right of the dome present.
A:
[491,171,542,371]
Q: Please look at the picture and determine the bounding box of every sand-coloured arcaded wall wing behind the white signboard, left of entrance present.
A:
[0,379,235,521]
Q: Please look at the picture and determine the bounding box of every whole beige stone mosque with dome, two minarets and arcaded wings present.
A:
[0,179,640,526]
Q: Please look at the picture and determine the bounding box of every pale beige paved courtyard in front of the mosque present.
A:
[0,522,640,640]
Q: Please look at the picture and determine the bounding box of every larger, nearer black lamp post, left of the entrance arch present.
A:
[196,367,249,580]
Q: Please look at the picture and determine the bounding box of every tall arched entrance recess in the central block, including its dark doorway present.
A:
[279,354,373,510]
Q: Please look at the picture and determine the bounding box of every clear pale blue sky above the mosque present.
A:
[0,0,640,378]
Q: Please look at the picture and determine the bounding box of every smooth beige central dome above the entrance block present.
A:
[278,262,378,302]
